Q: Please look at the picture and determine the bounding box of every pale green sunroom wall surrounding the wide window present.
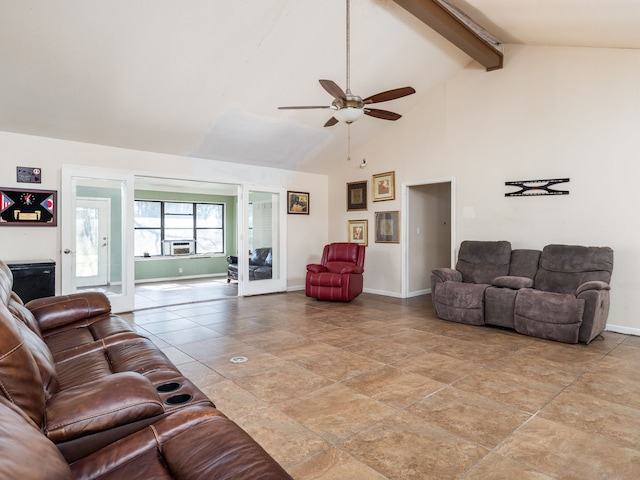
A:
[135,190,238,282]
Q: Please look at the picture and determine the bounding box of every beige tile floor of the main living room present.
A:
[125,286,640,480]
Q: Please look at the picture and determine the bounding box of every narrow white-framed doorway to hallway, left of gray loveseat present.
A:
[403,178,455,298]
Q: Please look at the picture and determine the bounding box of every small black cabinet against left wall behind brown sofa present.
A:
[7,260,56,303]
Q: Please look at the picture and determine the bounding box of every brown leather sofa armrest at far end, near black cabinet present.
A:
[25,292,111,331]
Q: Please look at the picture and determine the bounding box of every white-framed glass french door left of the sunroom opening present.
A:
[61,165,135,313]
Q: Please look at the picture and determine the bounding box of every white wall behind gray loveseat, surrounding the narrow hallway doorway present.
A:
[329,46,640,334]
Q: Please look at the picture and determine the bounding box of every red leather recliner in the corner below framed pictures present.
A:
[305,242,365,302]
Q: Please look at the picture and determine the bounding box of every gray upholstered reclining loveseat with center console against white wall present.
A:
[431,241,613,343]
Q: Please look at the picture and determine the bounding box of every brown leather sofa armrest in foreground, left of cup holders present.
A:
[44,372,164,443]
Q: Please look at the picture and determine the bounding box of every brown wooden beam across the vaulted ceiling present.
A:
[394,0,503,71]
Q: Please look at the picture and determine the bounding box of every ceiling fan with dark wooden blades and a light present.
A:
[278,0,416,127]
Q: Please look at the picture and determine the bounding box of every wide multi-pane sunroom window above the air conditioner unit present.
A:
[134,200,224,257]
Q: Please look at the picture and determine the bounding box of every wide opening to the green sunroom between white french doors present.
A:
[133,176,238,310]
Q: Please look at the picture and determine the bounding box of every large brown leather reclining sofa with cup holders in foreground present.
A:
[0,262,291,479]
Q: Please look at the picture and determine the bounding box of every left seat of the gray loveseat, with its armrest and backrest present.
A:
[431,241,511,325]
